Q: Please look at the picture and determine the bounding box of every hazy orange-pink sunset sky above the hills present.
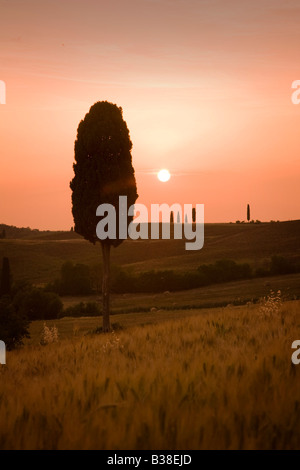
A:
[0,0,300,230]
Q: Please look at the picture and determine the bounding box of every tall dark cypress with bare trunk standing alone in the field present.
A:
[70,101,138,331]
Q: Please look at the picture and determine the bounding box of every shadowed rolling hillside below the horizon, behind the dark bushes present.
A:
[0,220,300,284]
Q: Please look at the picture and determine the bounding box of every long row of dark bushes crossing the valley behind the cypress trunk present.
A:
[45,255,300,295]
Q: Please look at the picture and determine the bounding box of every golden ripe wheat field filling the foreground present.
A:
[0,299,300,450]
